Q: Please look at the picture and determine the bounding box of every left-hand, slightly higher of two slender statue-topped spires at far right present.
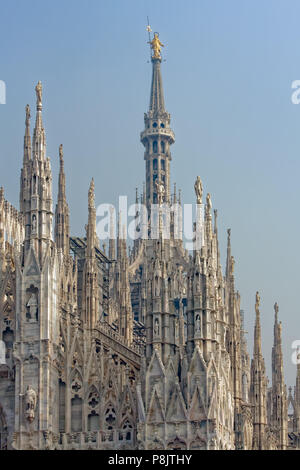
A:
[250,292,267,450]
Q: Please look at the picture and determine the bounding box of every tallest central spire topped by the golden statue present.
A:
[141,33,175,211]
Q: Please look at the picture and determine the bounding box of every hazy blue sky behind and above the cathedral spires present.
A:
[0,0,300,385]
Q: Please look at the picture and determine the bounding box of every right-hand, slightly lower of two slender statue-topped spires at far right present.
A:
[271,302,288,450]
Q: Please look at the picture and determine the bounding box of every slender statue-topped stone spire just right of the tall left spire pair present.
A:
[55,144,70,255]
